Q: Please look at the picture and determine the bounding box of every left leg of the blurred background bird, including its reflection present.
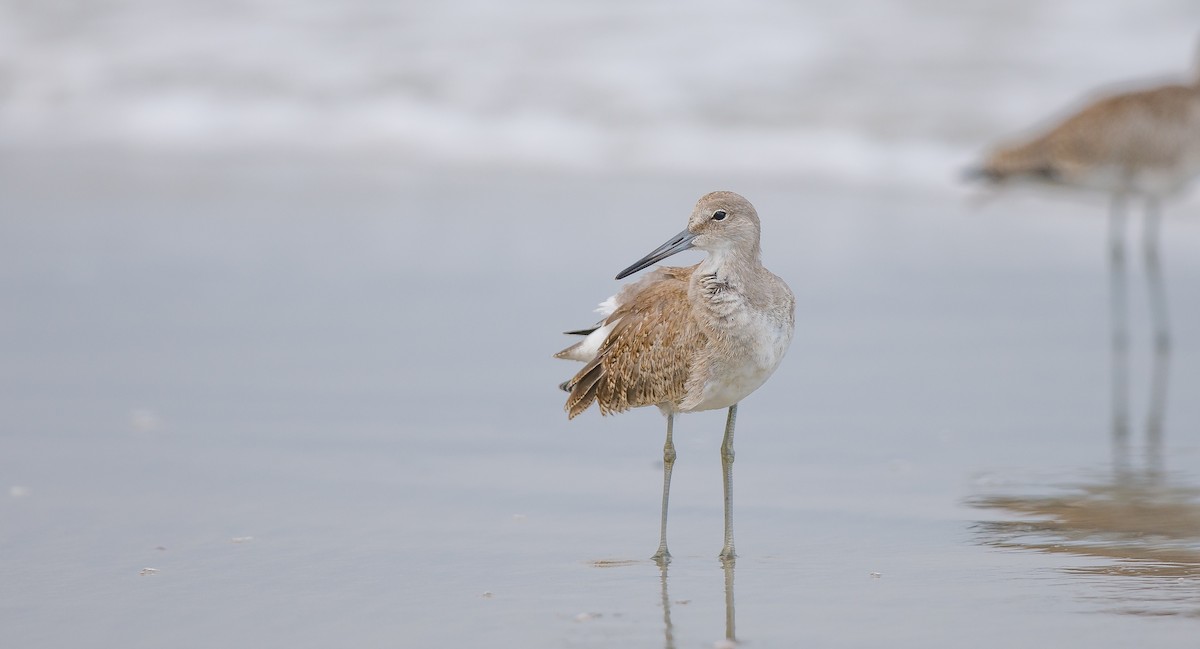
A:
[1109,192,1129,477]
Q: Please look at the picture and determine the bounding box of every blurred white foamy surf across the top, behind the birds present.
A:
[0,0,1198,179]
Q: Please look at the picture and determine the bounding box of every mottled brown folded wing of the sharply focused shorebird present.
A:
[564,268,704,419]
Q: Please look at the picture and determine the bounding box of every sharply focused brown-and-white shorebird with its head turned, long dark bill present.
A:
[554,192,796,564]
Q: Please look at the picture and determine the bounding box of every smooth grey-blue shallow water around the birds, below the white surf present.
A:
[0,154,1200,648]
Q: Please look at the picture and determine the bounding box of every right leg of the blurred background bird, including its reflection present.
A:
[1141,197,1171,477]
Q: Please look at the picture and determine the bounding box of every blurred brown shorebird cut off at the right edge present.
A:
[967,44,1200,460]
